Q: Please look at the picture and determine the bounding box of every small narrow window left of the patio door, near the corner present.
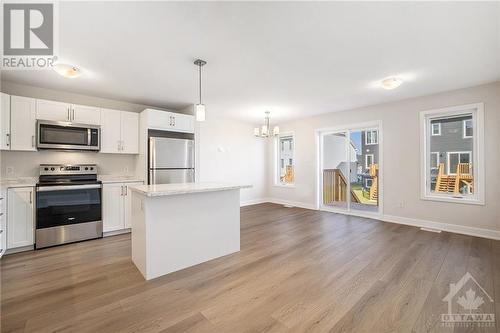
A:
[276,134,295,185]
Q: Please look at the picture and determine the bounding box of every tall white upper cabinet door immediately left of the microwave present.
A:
[10,96,36,151]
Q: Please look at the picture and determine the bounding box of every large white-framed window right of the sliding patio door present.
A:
[421,103,484,204]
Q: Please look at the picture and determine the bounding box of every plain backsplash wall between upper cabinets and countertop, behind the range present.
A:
[0,151,137,178]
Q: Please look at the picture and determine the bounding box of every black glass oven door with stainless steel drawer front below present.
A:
[35,184,102,249]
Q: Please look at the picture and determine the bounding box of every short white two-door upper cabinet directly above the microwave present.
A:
[36,99,101,125]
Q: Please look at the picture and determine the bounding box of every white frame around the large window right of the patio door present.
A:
[420,103,485,205]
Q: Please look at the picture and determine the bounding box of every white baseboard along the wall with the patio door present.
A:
[252,198,500,240]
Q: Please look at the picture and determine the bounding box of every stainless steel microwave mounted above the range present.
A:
[36,120,101,151]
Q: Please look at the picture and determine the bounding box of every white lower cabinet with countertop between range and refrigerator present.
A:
[102,182,142,232]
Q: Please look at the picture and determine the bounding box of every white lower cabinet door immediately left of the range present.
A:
[7,187,35,249]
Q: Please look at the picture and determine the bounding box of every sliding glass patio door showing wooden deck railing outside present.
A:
[320,126,380,213]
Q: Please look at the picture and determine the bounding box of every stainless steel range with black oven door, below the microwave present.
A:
[35,164,102,249]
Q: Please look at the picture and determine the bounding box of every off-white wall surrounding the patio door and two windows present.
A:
[267,82,500,231]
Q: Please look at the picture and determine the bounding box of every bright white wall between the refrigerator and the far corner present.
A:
[197,114,266,204]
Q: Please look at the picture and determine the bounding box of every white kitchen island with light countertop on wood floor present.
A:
[130,183,251,280]
